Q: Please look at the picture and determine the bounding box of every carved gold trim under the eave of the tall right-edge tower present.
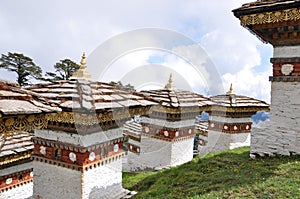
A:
[240,8,300,26]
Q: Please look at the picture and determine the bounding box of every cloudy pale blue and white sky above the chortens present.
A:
[0,0,272,102]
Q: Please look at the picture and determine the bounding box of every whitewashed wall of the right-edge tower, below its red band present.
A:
[251,82,300,156]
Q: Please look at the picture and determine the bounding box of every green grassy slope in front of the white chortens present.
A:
[123,147,300,199]
